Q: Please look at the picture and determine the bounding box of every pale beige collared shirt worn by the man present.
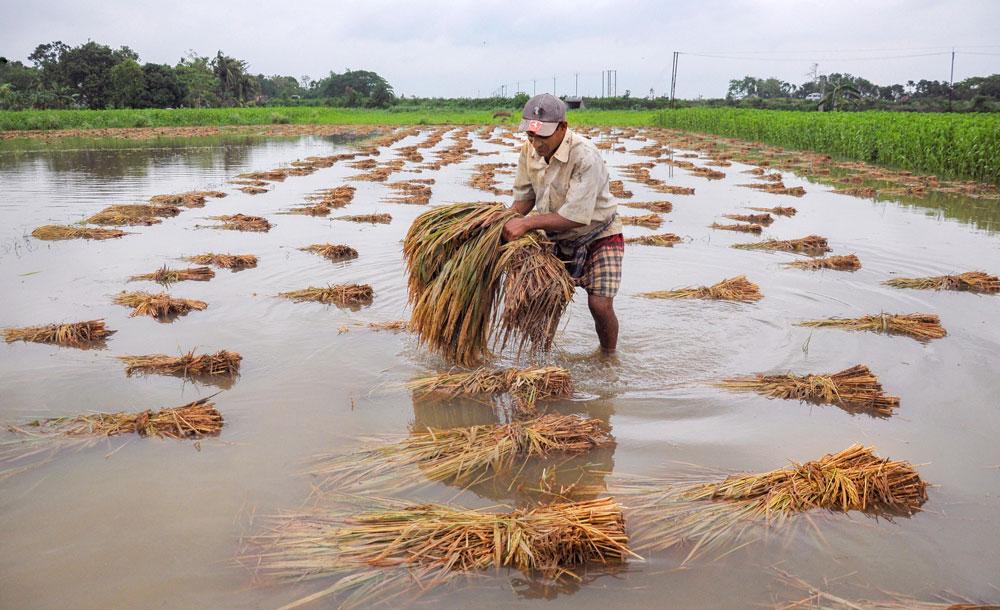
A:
[514,130,622,247]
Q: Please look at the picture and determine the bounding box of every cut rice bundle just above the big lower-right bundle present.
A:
[718,364,899,417]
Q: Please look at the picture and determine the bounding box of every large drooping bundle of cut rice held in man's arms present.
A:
[403,203,574,367]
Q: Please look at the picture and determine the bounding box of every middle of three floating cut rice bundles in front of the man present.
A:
[308,414,614,491]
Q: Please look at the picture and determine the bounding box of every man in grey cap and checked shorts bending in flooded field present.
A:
[503,93,625,354]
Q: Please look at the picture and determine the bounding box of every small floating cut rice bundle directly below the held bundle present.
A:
[407,366,573,405]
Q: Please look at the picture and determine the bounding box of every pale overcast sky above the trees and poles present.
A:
[0,0,1000,98]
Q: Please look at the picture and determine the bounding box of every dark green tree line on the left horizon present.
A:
[0,41,395,110]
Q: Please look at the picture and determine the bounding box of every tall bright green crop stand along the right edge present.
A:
[654,108,1000,184]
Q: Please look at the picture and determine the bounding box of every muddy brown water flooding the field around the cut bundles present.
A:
[0,126,1000,608]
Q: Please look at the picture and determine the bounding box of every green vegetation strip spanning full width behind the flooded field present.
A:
[0,107,1000,184]
